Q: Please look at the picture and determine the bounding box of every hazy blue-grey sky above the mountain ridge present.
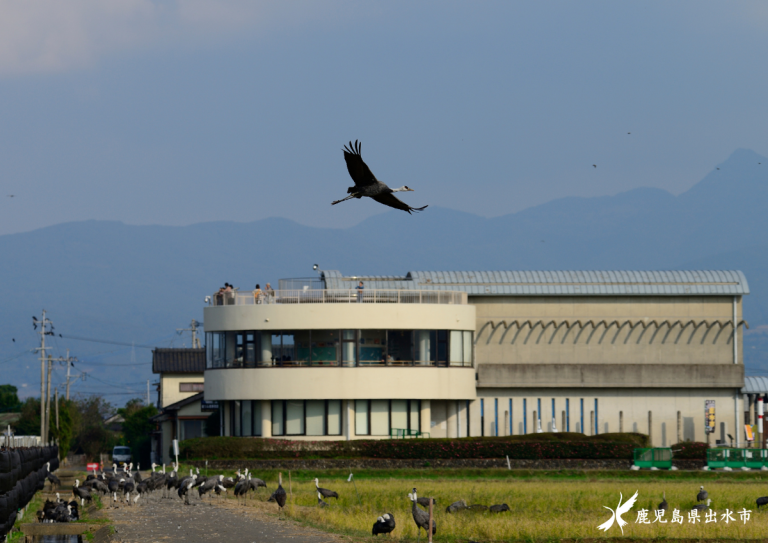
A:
[0,0,768,234]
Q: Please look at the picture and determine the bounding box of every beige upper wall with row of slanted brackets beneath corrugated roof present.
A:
[470,296,743,364]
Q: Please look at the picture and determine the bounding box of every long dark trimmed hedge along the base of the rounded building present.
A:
[179,432,648,460]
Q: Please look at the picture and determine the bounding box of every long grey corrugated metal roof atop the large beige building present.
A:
[323,270,749,296]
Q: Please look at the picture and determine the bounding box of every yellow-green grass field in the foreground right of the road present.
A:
[202,470,768,542]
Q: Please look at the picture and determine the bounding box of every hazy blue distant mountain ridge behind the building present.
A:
[0,149,768,393]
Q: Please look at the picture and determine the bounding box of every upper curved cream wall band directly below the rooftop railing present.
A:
[203,303,475,332]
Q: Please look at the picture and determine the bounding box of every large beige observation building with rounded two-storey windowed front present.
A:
[204,270,749,446]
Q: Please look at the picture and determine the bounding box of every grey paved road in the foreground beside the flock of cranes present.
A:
[104,496,339,543]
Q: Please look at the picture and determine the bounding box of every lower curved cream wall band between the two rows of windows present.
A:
[205,366,475,400]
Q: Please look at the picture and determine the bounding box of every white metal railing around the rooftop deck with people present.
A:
[207,289,467,305]
